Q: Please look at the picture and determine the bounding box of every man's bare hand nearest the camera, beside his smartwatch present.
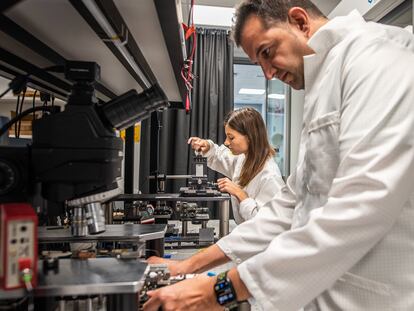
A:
[144,275,223,311]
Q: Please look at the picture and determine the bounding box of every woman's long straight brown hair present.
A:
[224,108,275,187]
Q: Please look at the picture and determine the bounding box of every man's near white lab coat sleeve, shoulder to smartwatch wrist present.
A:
[237,40,414,310]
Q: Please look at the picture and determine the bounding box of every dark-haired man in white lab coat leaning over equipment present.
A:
[145,0,414,311]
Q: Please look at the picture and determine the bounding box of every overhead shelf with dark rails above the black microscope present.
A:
[0,0,186,104]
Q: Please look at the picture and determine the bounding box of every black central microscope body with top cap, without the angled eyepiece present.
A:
[31,61,122,202]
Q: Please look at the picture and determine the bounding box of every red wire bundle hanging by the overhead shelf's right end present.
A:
[181,0,197,113]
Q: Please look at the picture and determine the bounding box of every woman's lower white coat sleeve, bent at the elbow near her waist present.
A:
[239,175,284,220]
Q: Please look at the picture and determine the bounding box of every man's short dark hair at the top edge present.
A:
[232,0,325,46]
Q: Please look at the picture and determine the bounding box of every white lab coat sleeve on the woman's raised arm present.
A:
[204,140,239,179]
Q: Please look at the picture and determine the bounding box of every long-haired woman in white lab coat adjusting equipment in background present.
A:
[188,108,284,224]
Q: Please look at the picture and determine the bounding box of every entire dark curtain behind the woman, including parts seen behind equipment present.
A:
[140,28,233,216]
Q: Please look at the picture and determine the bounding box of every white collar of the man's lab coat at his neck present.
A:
[303,10,365,91]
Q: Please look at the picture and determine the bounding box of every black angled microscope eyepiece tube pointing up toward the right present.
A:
[100,84,169,130]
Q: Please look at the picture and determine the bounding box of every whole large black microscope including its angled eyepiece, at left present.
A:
[0,61,169,235]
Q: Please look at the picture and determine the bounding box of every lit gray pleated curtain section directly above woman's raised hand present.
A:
[191,28,233,156]
